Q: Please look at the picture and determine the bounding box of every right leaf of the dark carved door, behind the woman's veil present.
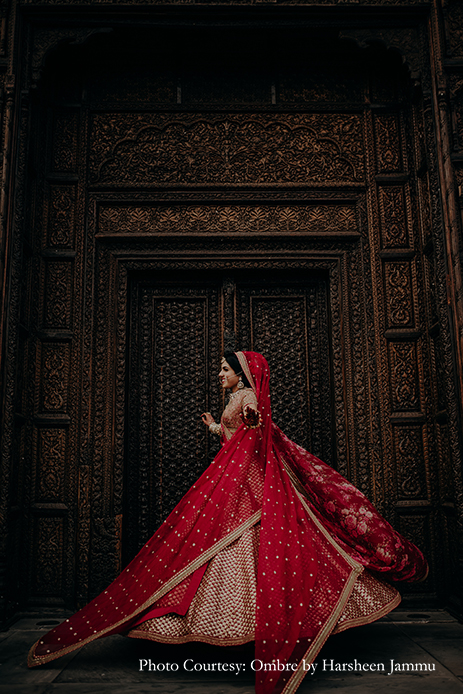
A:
[237,273,333,463]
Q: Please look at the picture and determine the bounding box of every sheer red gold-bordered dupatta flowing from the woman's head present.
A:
[29,352,426,694]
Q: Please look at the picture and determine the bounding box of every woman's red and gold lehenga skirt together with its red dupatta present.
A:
[29,352,427,694]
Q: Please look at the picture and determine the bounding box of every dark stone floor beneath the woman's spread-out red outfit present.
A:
[0,608,463,694]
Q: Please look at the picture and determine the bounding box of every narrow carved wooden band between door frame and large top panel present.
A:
[98,204,357,234]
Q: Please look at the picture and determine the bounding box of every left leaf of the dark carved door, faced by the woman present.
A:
[124,278,221,556]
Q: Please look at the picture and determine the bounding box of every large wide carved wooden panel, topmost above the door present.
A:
[89,113,365,185]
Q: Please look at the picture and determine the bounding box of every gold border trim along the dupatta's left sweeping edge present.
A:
[27,509,262,667]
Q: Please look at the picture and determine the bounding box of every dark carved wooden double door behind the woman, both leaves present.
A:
[123,273,334,561]
